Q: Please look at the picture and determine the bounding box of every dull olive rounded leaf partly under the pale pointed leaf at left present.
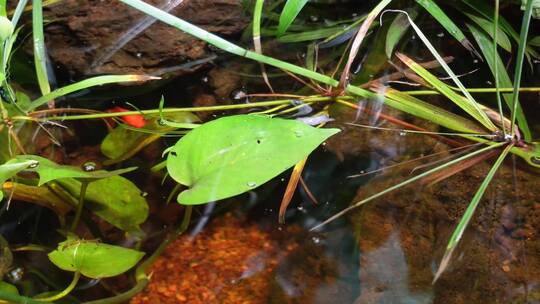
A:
[57,176,148,233]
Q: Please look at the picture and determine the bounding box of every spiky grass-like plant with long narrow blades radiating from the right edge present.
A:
[122,0,540,281]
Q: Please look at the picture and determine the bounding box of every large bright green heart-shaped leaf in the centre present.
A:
[167,115,339,205]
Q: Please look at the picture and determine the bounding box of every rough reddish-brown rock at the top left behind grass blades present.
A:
[41,0,248,77]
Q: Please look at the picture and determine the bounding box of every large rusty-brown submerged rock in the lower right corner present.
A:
[350,146,540,303]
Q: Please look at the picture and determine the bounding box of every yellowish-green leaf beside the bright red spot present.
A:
[101,112,199,165]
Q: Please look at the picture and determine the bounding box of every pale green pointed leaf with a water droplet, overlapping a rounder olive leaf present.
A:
[16,155,137,186]
